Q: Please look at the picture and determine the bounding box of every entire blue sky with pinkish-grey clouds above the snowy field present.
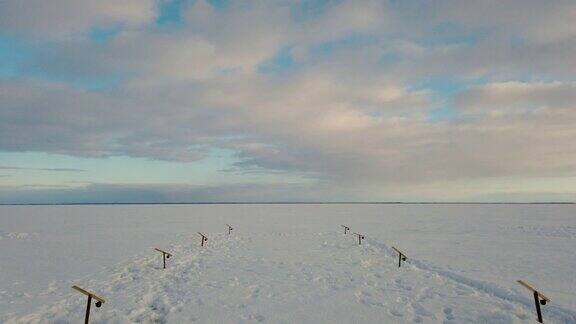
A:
[0,0,576,203]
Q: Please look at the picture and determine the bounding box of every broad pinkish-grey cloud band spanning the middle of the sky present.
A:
[0,71,576,192]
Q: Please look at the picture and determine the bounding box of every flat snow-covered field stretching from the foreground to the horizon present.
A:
[0,205,576,323]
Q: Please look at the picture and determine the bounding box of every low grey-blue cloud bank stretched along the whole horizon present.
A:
[0,179,576,204]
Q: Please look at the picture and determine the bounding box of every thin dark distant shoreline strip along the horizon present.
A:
[0,201,576,206]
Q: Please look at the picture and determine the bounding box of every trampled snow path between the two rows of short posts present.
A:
[3,230,576,323]
